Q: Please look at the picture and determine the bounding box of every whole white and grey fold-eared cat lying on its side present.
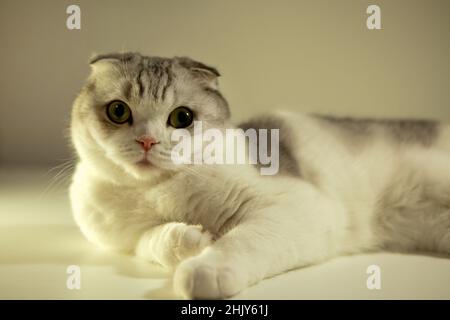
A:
[69,53,450,299]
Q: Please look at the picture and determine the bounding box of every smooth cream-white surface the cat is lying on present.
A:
[0,168,450,299]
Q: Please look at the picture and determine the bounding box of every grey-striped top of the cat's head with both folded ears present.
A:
[85,53,219,100]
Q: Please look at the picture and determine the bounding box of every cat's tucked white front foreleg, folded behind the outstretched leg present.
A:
[135,222,212,268]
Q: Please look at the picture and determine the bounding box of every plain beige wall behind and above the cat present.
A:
[0,0,450,165]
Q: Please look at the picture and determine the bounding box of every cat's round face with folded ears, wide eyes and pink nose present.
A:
[71,53,229,179]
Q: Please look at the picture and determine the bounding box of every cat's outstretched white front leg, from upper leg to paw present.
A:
[174,186,339,299]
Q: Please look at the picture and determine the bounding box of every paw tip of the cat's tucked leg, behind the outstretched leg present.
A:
[162,223,213,268]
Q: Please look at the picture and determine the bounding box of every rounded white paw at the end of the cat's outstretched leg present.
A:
[173,256,247,299]
